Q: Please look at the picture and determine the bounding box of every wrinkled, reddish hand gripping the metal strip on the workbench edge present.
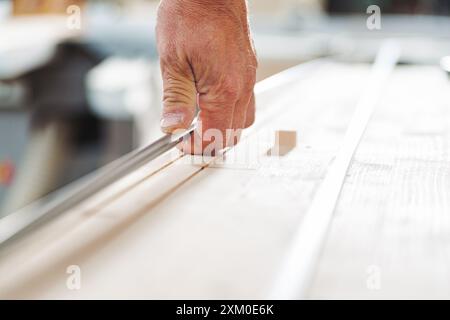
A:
[156,0,257,154]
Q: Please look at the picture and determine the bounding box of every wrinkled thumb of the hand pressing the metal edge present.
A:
[161,62,197,133]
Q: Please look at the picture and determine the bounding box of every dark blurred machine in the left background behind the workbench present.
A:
[0,38,109,216]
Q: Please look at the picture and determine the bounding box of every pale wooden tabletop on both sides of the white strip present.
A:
[0,62,450,299]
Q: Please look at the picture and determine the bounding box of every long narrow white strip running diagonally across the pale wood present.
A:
[269,40,400,299]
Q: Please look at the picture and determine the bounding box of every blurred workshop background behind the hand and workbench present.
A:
[0,0,450,217]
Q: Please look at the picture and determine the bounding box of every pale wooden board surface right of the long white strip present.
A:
[311,67,450,299]
